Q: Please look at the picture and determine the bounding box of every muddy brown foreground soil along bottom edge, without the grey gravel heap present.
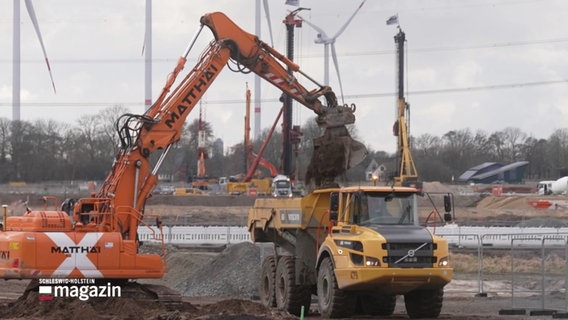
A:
[0,268,565,320]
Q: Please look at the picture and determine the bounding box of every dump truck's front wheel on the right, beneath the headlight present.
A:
[404,288,444,319]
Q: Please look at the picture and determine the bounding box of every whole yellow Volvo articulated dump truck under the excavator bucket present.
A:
[248,186,453,318]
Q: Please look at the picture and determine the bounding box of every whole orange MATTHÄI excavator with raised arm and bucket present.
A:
[0,12,366,279]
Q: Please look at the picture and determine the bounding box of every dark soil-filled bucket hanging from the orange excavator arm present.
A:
[306,126,368,188]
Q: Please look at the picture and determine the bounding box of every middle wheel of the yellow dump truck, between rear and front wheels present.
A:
[274,256,311,316]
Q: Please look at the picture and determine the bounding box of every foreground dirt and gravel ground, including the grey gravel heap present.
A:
[0,243,566,320]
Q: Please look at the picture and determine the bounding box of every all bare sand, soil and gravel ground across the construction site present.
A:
[0,183,568,320]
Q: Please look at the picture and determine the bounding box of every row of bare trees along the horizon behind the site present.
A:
[0,106,568,183]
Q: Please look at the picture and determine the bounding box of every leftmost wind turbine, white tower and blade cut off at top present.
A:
[12,0,56,121]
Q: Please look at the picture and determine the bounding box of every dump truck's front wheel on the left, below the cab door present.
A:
[317,257,356,318]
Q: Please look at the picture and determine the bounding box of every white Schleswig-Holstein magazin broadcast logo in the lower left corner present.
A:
[39,279,122,301]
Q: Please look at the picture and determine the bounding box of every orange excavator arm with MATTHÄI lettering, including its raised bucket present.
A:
[86,12,366,250]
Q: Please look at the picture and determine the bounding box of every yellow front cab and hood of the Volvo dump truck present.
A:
[318,187,452,294]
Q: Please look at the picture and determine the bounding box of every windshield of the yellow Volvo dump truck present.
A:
[351,192,415,226]
